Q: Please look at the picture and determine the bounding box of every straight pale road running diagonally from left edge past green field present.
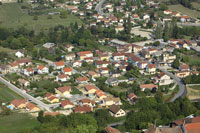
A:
[0,77,58,112]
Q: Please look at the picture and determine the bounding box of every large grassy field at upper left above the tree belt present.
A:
[0,3,81,33]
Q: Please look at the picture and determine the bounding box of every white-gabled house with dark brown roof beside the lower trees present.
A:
[108,105,126,117]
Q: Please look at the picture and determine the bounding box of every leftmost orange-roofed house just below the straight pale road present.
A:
[10,99,27,109]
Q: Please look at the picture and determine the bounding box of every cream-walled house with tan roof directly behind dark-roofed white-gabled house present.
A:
[102,97,122,106]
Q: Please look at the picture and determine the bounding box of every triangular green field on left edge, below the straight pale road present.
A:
[0,83,23,102]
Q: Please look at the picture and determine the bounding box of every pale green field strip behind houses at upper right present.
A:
[168,4,200,18]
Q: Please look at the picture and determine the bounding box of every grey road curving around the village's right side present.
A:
[158,67,187,102]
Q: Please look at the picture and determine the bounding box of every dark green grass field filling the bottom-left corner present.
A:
[0,113,39,133]
